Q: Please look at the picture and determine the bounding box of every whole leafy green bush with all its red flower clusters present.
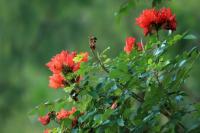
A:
[30,1,200,133]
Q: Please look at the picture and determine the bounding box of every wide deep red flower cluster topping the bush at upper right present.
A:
[136,8,176,36]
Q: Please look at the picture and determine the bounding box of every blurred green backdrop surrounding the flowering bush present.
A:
[0,0,200,133]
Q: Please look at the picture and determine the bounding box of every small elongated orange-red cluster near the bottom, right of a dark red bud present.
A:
[56,107,76,120]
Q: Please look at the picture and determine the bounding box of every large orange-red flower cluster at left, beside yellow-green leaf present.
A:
[46,51,88,89]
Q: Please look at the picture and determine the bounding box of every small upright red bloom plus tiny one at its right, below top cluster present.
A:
[124,37,144,54]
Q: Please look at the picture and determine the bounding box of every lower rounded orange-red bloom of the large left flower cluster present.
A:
[49,74,66,89]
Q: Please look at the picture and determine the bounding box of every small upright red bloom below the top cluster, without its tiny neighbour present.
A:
[124,37,135,54]
